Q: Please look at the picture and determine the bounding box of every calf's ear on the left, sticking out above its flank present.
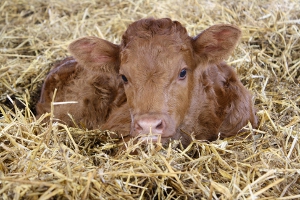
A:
[69,36,119,70]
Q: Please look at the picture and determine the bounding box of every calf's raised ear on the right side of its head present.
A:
[193,25,241,63]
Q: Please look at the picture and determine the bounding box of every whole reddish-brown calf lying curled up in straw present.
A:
[37,18,256,145]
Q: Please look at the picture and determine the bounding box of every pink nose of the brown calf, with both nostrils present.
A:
[135,118,165,134]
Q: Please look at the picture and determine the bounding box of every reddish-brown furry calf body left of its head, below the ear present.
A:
[37,56,126,129]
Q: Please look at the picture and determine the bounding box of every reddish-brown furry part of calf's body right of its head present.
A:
[190,63,257,141]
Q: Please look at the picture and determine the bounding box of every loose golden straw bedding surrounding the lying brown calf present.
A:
[0,0,300,199]
